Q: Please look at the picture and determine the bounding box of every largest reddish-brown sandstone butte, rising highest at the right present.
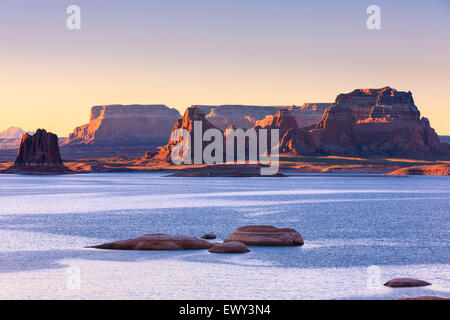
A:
[262,87,441,156]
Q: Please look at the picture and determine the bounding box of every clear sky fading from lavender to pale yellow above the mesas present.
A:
[0,0,450,137]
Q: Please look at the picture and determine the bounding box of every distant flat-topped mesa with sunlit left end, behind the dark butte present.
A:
[62,105,180,146]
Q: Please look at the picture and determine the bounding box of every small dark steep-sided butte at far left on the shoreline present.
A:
[5,129,70,174]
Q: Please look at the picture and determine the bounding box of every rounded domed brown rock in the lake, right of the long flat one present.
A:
[224,225,304,246]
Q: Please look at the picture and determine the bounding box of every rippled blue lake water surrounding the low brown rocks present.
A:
[0,173,450,299]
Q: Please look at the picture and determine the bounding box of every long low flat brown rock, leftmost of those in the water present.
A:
[87,233,214,250]
